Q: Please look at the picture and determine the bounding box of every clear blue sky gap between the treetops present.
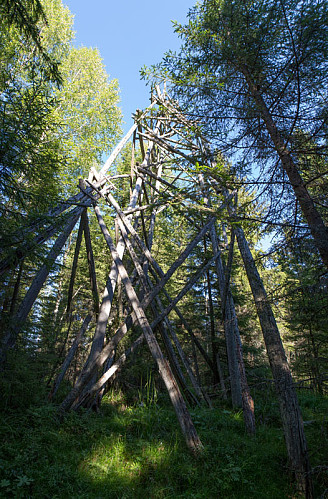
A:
[63,0,195,135]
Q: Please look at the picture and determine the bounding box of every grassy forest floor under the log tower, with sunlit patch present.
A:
[0,391,328,499]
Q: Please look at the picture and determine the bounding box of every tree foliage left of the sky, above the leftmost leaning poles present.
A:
[0,0,121,241]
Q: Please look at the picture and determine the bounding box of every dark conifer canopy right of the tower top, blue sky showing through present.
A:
[143,0,328,265]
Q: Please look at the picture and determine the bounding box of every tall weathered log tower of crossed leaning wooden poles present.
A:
[0,86,311,497]
